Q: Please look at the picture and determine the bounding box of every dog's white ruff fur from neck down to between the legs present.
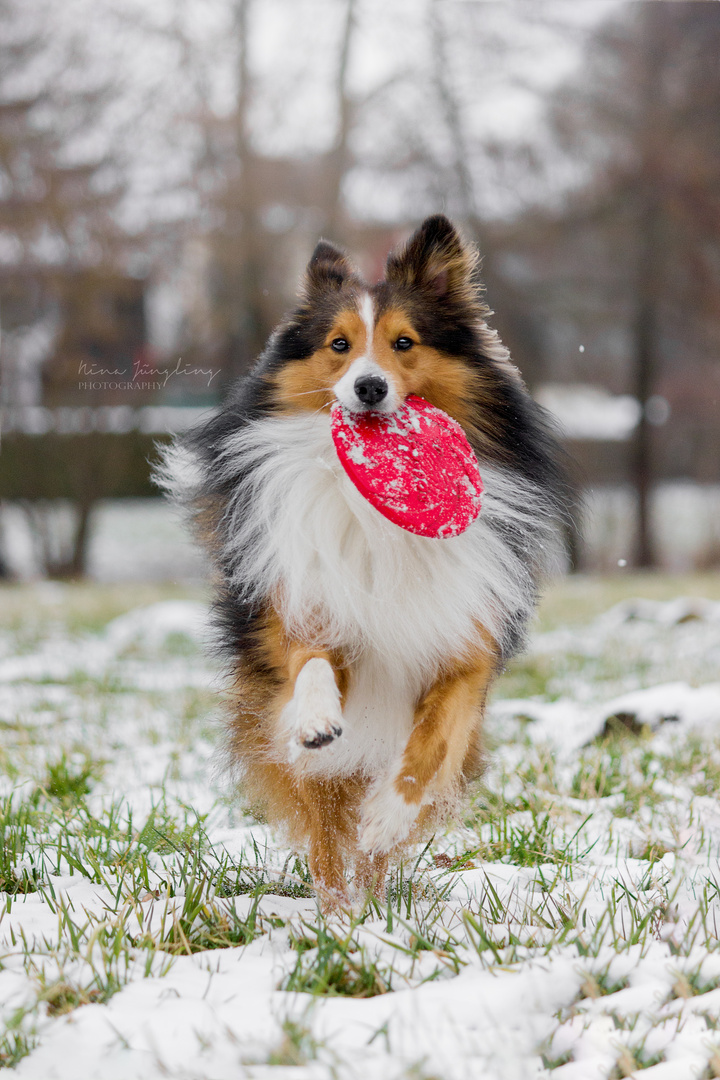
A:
[184,411,552,777]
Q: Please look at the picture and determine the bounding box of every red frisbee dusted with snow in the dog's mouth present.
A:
[330,394,483,538]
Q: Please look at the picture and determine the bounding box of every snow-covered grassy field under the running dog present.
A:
[0,578,720,1080]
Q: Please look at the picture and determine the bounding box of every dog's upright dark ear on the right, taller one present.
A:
[385,214,477,303]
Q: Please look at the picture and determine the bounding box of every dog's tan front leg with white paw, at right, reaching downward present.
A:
[359,651,497,854]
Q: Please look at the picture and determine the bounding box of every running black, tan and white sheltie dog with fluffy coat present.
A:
[160,215,566,906]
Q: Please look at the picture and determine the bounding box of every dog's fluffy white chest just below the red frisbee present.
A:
[228,415,502,669]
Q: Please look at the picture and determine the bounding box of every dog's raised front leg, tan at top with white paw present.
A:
[280,644,347,761]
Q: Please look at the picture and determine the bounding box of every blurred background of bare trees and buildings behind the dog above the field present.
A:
[0,0,720,582]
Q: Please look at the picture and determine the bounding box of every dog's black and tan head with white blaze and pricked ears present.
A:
[272,215,496,424]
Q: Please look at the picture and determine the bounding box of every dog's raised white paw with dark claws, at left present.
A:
[281,657,342,761]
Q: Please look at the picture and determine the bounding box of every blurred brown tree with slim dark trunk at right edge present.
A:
[544,0,720,567]
